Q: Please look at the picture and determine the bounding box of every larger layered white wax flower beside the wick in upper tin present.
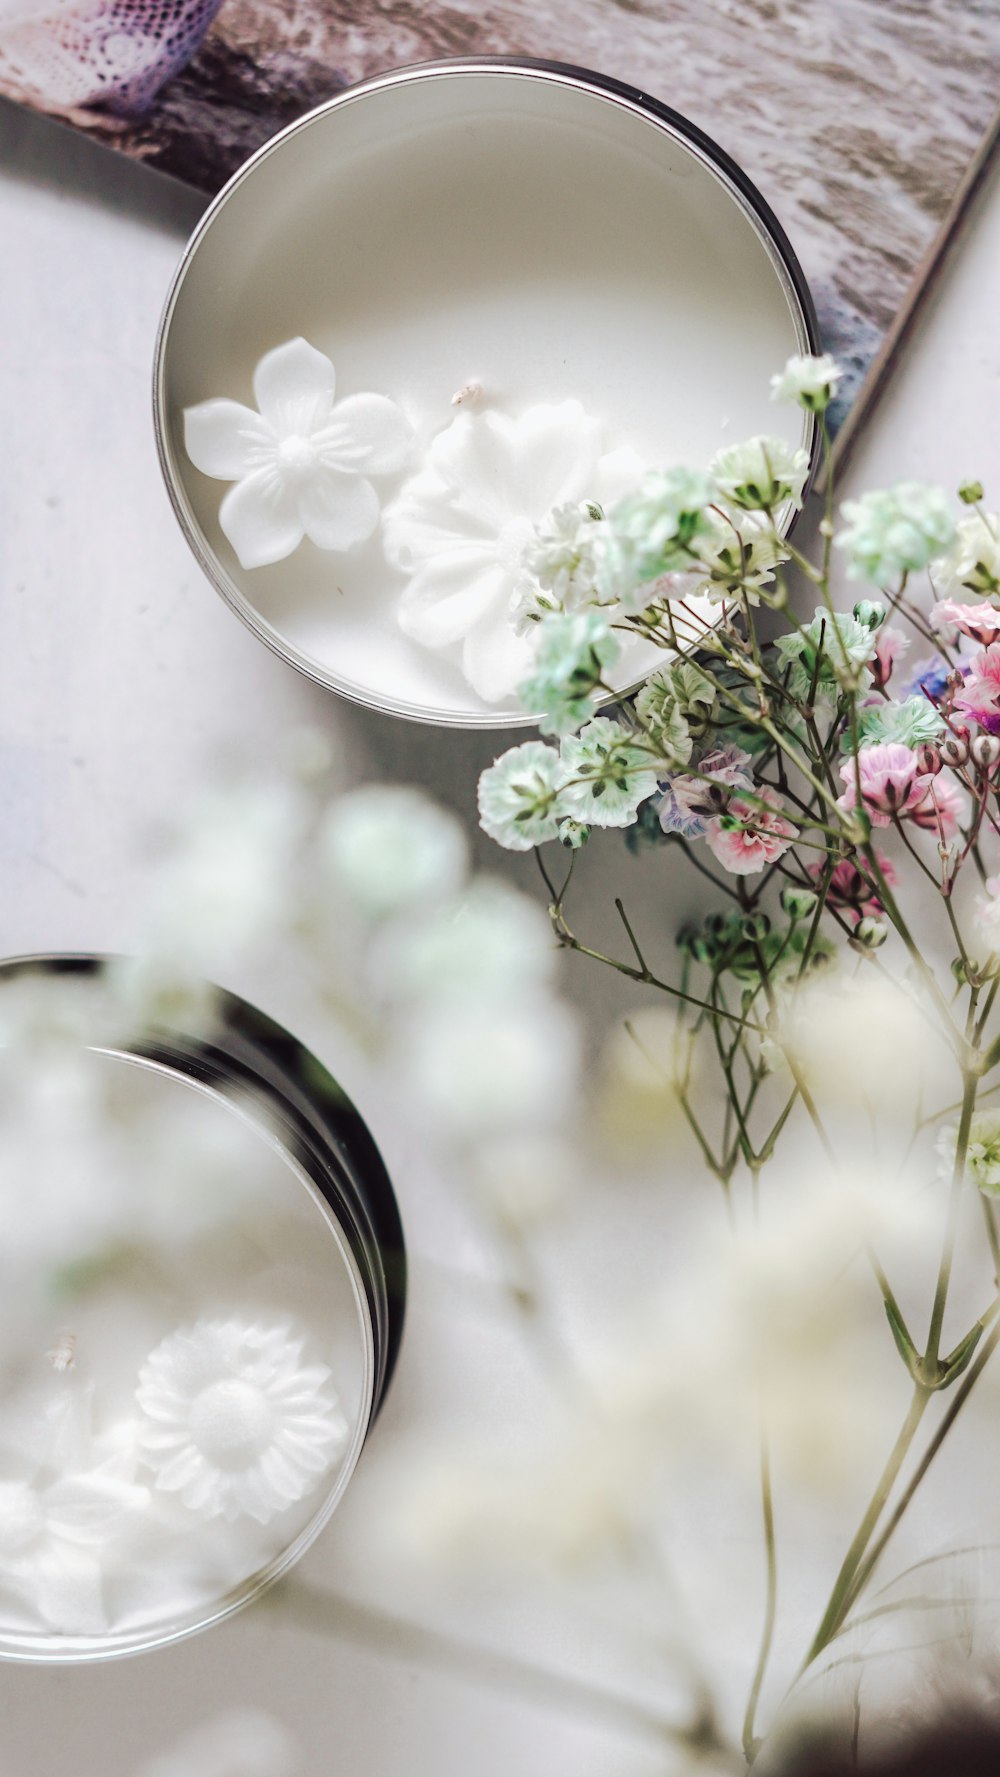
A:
[382,402,641,704]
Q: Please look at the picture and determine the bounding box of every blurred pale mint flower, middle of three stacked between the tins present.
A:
[375,874,556,1000]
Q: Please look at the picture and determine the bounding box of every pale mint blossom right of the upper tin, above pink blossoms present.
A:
[833,482,956,586]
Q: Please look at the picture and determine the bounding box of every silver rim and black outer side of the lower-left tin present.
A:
[0,954,407,1663]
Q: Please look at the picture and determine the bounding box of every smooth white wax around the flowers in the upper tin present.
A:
[158,71,805,727]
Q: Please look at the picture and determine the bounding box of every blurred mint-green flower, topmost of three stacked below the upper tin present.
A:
[320,784,469,919]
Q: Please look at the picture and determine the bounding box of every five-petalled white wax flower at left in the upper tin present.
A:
[185,339,412,567]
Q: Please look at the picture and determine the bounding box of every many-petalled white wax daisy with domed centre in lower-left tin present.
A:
[135,1320,348,1525]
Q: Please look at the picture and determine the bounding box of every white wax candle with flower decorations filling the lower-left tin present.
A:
[0,1048,373,1658]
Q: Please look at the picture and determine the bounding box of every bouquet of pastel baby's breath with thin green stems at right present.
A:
[465,355,1000,1761]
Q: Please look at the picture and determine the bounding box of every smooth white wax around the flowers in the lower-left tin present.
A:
[0,1054,373,1658]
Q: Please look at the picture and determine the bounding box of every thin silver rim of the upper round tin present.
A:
[153,55,822,732]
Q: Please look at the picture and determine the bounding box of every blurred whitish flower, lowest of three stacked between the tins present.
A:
[398,993,579,1139]
